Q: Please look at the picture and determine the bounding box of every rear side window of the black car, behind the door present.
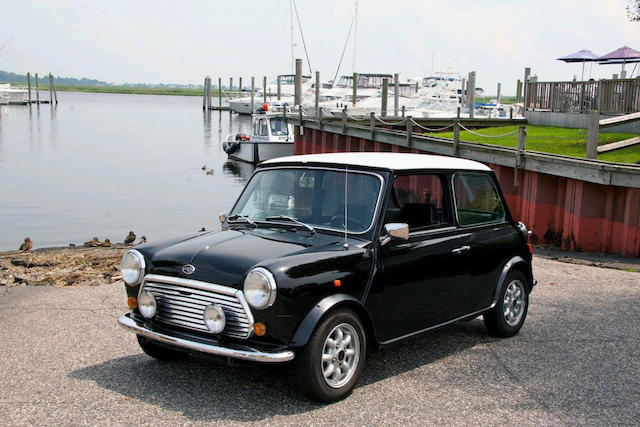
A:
[453,172,505,225]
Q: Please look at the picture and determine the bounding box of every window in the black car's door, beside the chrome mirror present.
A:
[384,174,453,231]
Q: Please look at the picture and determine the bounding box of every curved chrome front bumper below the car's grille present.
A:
[118,313,294,363]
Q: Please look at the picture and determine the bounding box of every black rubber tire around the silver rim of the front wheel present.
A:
[296,310,367,403]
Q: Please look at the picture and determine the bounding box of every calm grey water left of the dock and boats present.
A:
[0,93,252,250]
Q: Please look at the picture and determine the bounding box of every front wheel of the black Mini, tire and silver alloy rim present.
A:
[296,310,367,403]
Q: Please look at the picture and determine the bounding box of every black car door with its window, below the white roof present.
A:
[378,174,472,341]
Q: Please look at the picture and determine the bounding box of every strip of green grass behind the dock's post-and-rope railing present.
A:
[429,125,640,163]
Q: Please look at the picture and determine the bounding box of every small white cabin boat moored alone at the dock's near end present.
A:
[222,106,294,164]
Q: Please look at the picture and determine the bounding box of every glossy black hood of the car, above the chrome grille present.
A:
[145,229,356,288]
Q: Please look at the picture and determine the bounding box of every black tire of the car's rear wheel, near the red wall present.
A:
[483,270,529,337]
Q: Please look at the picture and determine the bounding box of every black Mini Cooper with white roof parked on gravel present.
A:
[119,153,535,402]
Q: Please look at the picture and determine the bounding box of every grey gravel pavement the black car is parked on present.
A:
[0,258,640,425]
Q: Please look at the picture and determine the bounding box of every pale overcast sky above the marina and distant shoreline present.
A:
[0,0,640,94]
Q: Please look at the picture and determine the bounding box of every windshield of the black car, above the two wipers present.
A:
[229,168,381,233]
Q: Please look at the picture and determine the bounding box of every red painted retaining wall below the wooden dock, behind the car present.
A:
[294,128,640,257]
